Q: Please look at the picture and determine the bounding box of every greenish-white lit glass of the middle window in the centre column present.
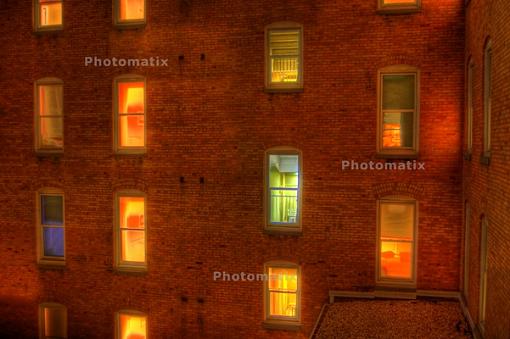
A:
[269,155,299,223]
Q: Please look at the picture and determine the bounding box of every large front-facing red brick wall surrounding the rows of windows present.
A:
[0,0,470,338]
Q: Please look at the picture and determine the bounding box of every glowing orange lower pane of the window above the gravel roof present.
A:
[381,241,412,279]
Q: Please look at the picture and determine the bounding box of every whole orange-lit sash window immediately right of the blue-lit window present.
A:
[116,193,147,269]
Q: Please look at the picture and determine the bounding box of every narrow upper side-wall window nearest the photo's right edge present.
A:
[483,41,492,157]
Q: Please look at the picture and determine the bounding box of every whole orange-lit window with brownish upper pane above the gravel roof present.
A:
[379,198,416,282]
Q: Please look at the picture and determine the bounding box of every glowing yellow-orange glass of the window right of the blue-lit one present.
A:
[119,197,145,262]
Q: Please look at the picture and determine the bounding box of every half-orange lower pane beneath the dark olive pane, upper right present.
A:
[383,112,414,147]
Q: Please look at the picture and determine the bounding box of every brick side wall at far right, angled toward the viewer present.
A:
[464,0,510,339]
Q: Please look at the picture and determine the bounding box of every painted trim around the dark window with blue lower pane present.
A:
[36,188,66,266]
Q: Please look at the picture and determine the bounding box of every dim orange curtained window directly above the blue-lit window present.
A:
[35,78,64,152]
